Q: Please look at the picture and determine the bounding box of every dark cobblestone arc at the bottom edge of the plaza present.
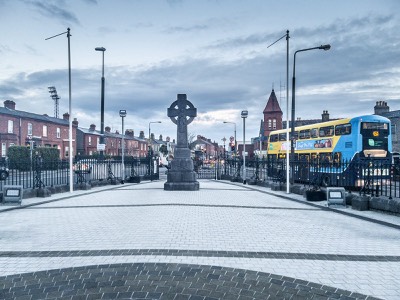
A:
[0,263,373,300]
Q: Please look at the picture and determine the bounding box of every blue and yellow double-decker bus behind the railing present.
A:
[268,115,392,187]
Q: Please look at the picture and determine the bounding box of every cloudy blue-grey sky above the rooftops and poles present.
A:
[0,0,400,144]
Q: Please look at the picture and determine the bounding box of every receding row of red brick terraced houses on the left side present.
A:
[0,100,152,159]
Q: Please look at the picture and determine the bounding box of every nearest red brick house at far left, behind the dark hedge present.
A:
[0,100,78,159]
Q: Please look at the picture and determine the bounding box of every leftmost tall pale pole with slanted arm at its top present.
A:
[45,28,74,193]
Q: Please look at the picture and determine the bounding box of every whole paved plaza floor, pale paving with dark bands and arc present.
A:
[0,180,400,300]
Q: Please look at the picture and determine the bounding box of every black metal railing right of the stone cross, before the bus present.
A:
[195,157,400,198]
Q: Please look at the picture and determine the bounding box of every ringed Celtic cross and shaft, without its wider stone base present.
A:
[168,94,197,148]
